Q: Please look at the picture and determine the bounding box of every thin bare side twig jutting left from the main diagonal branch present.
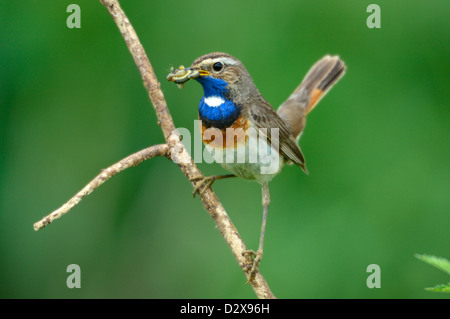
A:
[33,144,169,230]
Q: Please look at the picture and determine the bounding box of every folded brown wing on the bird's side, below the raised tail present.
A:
[249,100,307,172]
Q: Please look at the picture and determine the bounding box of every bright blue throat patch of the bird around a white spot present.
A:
[196,76,240,128]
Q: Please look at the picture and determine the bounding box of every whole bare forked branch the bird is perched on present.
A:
[34,0,275,299]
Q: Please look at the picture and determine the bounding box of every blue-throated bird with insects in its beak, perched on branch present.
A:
[167,52,346,282]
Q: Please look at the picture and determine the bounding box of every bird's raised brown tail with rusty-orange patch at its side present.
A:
[277,55,346,137]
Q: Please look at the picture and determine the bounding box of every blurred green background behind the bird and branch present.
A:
[0,0,450,298]
